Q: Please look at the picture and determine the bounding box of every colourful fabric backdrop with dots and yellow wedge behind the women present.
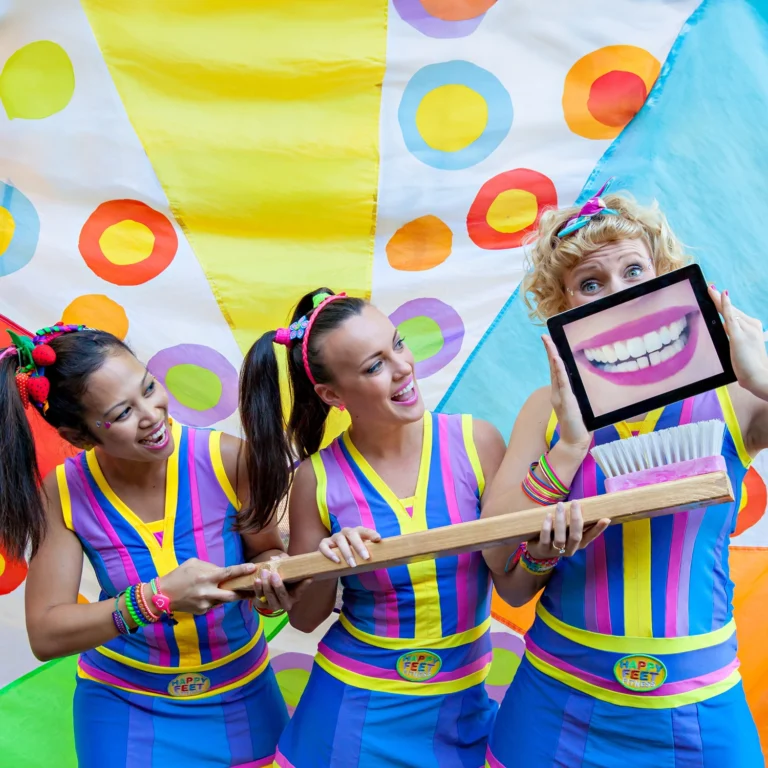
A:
[0,0,768,768]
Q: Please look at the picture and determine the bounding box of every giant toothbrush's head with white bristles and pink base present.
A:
[590,420,726,493]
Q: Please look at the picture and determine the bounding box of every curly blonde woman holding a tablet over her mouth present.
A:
[483,183,768,768]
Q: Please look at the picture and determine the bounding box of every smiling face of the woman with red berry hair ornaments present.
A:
[77,351,173,462]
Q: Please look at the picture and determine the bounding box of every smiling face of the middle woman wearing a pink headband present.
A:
[317,305,424,424]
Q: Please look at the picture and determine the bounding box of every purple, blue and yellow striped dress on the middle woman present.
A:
[275,413,496,768]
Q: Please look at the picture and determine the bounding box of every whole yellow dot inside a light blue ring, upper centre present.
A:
[416,85,488,152]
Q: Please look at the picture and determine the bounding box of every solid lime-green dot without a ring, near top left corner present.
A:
[0,40,75,120]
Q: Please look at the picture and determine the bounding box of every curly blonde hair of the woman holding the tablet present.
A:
[522,194,690,323]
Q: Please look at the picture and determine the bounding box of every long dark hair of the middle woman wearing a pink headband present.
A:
[237,288,365,531]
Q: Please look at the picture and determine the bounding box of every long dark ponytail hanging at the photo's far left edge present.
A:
[0,355,45,560]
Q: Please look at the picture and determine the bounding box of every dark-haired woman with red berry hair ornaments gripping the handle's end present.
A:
[0,325,302,768]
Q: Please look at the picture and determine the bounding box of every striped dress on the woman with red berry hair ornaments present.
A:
[57,424,288,768]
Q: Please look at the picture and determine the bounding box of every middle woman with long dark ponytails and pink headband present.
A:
[240,288,504,768]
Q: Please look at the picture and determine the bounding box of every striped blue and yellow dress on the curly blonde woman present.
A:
[486,389,764,768]
